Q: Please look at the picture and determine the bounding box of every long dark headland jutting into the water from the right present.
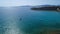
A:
[31,5,60,11]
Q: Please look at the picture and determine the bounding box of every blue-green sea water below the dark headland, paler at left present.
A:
[0,7,60,34]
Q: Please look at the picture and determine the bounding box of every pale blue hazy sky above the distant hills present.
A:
[0,0,60,6]
